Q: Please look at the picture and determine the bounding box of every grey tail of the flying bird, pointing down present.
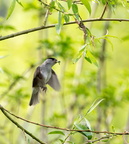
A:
[29,87,40,106]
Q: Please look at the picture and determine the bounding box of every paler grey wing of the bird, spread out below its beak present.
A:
[47,70,61,91]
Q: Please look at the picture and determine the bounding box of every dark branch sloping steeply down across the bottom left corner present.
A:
[0,105,45,144]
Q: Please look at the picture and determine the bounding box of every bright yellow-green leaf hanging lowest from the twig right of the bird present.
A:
[85,51,98,66]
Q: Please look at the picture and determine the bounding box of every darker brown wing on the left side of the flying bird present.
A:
[32,66,44,87]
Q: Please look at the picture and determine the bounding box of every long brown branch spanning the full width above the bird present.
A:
[0,18,129,41]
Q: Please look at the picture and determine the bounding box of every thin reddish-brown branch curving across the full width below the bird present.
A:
[0,105,129,136]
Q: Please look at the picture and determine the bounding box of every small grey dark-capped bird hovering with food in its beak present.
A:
[29,58,61,106]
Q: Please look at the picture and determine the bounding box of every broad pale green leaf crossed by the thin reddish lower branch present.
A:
[74,118,93,140]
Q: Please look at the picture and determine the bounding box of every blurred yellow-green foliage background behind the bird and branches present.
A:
[0,0,129,144]
